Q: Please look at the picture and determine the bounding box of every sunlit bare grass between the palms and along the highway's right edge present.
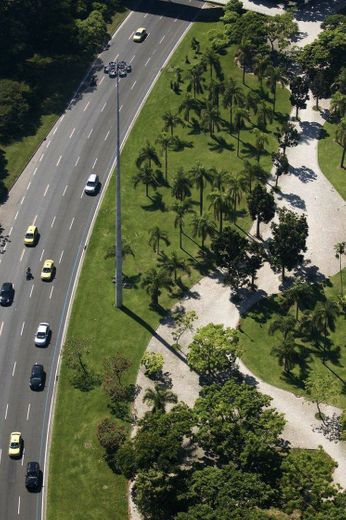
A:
[48,12,290,520]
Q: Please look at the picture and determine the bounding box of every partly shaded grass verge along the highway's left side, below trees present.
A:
[0,10,128,195]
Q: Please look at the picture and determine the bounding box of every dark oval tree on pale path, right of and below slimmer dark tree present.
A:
[269,208,308,280]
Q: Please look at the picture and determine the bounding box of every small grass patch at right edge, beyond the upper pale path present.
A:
[318,122,346,200]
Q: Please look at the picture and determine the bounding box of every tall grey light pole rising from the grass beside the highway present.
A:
[115,61,123,309]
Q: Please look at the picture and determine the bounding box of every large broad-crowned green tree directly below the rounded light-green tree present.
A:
[194,379,285,476]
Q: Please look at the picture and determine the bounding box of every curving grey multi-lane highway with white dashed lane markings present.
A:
[0,0,202,520]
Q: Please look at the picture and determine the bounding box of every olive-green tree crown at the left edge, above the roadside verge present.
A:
[0,79,30,142]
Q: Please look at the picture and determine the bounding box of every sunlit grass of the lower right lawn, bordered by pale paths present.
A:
[240,269,346,407]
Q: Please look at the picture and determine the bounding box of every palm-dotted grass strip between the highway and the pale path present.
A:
[48,2,298,520]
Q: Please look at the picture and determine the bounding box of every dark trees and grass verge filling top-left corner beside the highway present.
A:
[0,0,127,202]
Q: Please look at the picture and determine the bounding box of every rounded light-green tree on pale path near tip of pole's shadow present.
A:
[187,323,239,378]
